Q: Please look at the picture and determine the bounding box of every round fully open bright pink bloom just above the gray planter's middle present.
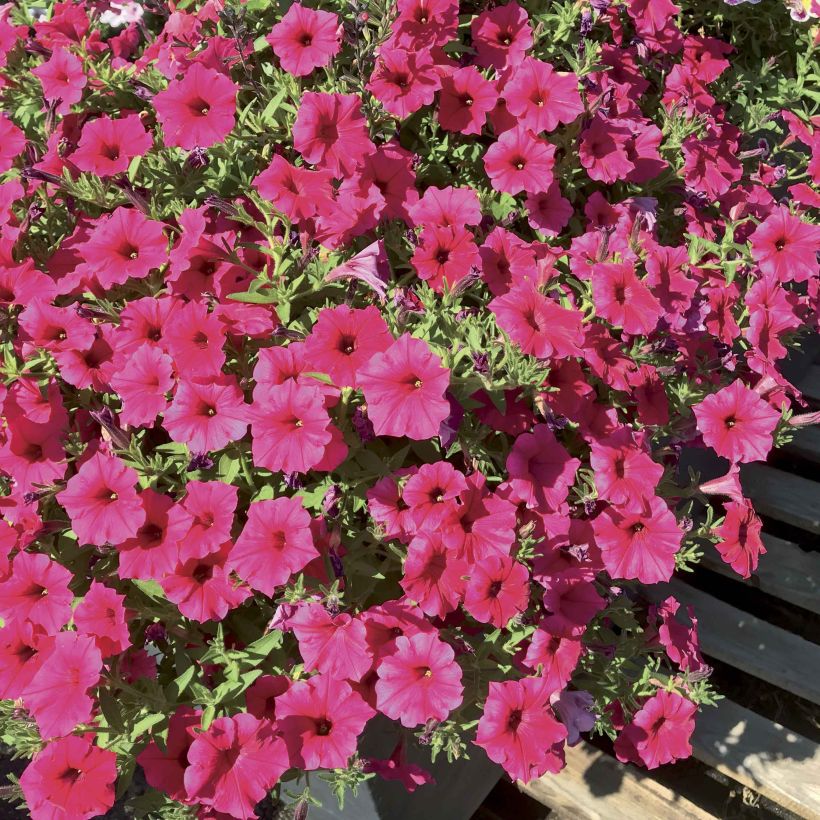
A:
[376,633,464,728]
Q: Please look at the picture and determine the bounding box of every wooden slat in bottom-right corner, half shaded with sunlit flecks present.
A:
[692,700,820,820]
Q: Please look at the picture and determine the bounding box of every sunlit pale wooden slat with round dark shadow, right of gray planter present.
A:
[519,742,714,820]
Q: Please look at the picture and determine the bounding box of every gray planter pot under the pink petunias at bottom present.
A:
[286,717,502,820]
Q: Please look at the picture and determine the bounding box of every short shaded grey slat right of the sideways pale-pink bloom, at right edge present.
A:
[740,464,820,535]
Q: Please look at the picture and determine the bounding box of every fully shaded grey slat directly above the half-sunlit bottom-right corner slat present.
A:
[664,579,820,704]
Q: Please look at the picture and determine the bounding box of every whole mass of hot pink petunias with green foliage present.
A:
[0,0,820,820]
